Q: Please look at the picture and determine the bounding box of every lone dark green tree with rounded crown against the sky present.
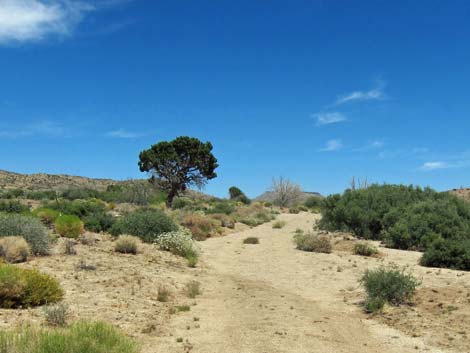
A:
[139,136,218,207]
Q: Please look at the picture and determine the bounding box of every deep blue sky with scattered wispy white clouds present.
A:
[0,0,470,197]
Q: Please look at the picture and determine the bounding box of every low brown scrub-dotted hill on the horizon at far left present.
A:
[0,170,119,191]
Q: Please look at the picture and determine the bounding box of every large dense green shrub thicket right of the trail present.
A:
[319,185,470,256]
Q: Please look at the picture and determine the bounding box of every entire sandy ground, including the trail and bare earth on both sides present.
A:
[0,212,470,353]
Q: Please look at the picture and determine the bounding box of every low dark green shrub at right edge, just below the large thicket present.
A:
[420,239,470,271]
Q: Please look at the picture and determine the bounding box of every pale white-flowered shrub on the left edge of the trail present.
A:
[156,228,199,267]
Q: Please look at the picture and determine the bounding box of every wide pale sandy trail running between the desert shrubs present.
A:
[153,213,452,353]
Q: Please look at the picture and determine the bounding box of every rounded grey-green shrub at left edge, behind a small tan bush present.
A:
[0,214,51,255]
